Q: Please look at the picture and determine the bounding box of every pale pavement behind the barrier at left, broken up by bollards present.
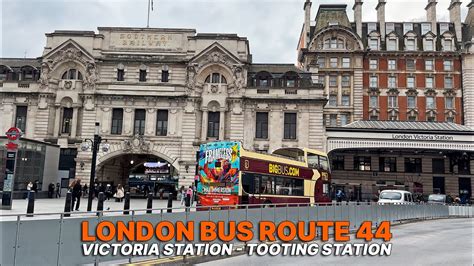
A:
[0,197,189,220]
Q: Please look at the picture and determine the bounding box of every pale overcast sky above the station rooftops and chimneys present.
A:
[0,0,470,63]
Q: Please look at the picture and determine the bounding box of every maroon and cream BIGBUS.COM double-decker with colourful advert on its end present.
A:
[197,142,331,206]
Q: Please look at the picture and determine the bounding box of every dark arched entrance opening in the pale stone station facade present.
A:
[96,154,178,197]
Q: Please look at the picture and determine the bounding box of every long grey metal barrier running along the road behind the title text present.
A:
[0,203,474,265]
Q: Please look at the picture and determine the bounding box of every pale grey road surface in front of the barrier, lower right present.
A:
[200,219,474,266]
